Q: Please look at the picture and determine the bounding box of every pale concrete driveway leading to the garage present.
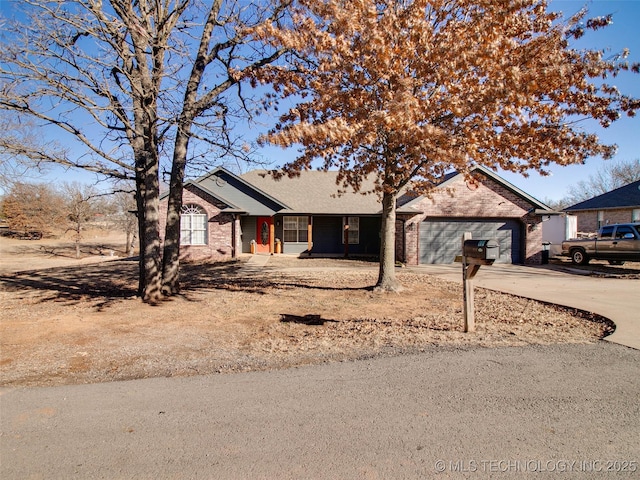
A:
[411,264,640,350]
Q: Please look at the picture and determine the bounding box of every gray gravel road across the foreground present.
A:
[0,341,640,480]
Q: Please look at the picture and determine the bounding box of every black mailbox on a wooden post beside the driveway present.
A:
[456,232,500,332]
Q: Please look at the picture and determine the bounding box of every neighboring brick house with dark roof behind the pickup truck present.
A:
[564,180,640,233]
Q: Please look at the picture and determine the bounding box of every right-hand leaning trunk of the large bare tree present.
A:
[162,128,189,295]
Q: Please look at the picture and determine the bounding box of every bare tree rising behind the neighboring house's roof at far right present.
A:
[561,158,640,207]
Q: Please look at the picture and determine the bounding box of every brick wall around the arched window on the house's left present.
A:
[160,187,240,260]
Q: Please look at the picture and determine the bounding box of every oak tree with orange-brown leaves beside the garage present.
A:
[255,0,638,290]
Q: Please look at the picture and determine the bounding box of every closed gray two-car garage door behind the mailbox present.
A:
[419,218,523,264]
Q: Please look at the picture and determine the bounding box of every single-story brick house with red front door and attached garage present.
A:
[161,167,550,265]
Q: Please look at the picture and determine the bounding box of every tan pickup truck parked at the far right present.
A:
[562,223,640,265]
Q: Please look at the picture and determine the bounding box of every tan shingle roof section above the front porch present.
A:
[240,170,381,215]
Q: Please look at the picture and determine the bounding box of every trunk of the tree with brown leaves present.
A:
[375,192,403,292]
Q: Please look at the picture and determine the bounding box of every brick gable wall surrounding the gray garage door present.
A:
[396,175,542,265]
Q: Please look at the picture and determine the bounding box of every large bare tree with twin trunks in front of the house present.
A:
[0,0,286,302]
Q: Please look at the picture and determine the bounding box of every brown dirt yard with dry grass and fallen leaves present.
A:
[0,234,612,386]
